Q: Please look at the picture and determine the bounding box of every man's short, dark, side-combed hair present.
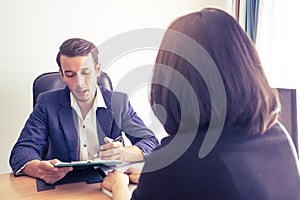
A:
[56,38,98,69]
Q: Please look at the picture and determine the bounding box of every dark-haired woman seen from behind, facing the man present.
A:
[102,8,300,200]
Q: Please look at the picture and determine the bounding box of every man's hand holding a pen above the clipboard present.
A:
[99,137,144,162]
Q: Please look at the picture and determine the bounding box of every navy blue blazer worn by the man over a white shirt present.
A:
[10,87,158,173]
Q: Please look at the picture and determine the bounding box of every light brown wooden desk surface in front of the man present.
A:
[0,174,111,200]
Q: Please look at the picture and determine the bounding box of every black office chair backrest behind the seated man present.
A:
[32,72,113,107]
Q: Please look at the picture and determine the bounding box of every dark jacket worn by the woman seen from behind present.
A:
[132,124,300,200]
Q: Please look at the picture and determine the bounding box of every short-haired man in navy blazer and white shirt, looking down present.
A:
[10,38,158,184]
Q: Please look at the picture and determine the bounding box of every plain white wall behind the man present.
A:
[0,0,231,173]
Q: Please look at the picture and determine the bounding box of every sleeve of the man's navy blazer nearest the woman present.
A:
[111,92,158,155]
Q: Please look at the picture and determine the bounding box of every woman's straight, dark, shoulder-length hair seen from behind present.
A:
[150,8,280,134]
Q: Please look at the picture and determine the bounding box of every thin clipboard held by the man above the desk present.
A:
[54,160,123,168]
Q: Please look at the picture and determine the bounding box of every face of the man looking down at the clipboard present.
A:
[60,55,100,103]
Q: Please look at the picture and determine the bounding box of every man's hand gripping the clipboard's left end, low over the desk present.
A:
[22,159,73,184]
